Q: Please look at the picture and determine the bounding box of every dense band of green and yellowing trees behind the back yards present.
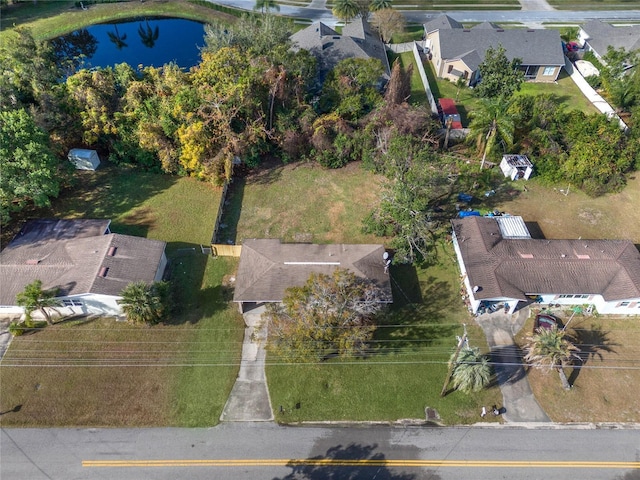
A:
[0,15,640,261]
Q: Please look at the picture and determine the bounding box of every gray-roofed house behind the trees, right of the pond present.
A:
[291,18,391,84]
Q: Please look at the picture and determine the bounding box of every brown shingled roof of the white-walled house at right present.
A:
[452,217,640,301]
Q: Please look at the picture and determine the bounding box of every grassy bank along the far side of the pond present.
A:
[0,0,236,40]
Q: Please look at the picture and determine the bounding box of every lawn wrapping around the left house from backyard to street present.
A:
[0,168,244,426]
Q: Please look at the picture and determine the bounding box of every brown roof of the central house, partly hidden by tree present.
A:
[233,239,392,311]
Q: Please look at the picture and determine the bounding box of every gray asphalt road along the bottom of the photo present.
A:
[0,423,640,480]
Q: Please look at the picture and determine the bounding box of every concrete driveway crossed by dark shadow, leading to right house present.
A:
[476,308,551,423]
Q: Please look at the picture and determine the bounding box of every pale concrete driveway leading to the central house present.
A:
[220,307,273,422]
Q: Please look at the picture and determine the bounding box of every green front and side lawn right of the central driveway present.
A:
[267,247,502,424]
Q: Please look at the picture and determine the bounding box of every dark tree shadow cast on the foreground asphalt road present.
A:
[273,443,430,480]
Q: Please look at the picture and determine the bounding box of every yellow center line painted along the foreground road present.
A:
[82,458,640,469]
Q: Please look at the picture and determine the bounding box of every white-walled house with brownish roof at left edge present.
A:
[0,219,167,315]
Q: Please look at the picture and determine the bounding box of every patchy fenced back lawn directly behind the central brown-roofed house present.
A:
[222,163,382,244]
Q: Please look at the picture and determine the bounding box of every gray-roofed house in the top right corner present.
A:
[578,20,640,59]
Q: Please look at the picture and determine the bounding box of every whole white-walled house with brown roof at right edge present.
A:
[451,216,640,315]
